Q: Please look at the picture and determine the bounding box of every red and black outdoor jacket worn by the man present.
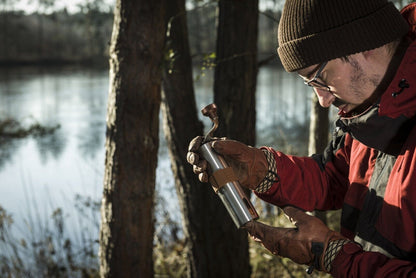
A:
[258,3,416,277]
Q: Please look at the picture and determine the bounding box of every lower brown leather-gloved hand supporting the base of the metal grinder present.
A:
[244,206,350,272]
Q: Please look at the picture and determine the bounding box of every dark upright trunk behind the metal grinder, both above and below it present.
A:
[214,0,258,277]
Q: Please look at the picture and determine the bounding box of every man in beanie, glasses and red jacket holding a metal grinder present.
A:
[187,0,416,277]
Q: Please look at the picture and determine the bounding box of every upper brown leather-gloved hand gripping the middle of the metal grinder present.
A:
[186,136,268,190]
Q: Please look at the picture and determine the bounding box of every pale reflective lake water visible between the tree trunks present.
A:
[0,64,332,248]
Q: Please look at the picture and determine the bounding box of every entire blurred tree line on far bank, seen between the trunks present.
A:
[0,1,280,67]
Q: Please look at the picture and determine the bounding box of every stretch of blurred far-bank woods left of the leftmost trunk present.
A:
[0,11,112,64]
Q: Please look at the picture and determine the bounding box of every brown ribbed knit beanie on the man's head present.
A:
[278,0,409,72]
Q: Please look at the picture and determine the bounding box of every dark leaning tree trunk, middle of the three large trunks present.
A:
[162,0,229,278]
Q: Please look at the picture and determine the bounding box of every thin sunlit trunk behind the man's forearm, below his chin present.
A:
[308,93,329,223]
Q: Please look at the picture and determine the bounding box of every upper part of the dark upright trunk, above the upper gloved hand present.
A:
[214,0,258,145]
